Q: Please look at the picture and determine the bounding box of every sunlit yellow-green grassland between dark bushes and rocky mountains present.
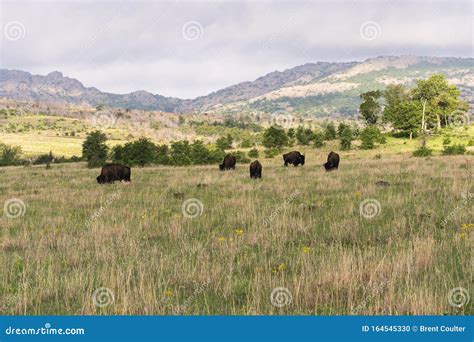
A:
[0,109,474,157]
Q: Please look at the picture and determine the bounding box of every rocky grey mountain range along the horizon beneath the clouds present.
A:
[0,56,474,116]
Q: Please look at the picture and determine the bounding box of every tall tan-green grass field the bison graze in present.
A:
[0,148,474,315]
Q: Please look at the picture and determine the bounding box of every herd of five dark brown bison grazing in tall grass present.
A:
[97,151,339,184]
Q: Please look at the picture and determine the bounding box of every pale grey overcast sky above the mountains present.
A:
[1,0,473,98]
